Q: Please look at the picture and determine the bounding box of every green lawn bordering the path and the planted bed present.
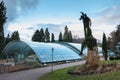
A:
[38,60,120,80]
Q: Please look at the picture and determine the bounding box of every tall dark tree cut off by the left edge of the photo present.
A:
[0,1,7,53]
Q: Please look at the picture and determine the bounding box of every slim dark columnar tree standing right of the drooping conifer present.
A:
[102,33,108,60]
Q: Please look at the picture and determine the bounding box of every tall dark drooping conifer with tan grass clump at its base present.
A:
[79,12,99,66]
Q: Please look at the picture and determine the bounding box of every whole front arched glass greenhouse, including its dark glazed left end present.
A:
[2,41,82,63]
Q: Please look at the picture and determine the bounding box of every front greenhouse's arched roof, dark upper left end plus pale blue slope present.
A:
[3,41,81,63]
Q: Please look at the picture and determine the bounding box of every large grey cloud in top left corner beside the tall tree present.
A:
[0,0,40,35]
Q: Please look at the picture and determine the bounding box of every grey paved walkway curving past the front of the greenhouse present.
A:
[0,61,85,80]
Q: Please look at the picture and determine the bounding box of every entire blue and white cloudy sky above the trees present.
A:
[3,0,120,40]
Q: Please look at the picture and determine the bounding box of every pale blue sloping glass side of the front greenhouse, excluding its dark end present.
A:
[26,42,81,62]
